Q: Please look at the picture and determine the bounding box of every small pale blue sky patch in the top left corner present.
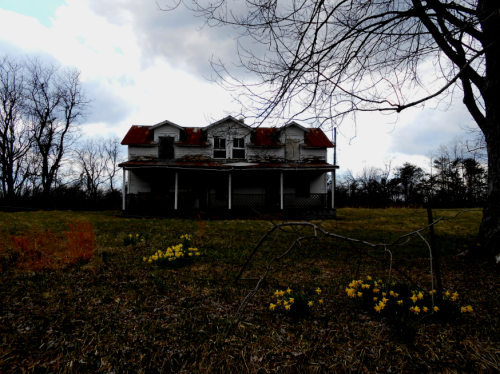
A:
[0,0,66,28]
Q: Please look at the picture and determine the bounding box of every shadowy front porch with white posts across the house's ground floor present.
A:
[123,163,334,216]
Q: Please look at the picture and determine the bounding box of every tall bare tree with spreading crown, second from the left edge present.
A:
[26,58,89,197]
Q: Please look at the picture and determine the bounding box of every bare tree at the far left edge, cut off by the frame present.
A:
[0,56,31,198]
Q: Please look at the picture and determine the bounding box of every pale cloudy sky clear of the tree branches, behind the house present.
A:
[0,0,474,177]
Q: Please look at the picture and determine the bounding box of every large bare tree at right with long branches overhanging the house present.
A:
[167,0,500,255]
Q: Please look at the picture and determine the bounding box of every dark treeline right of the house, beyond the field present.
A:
[335,139,487,208]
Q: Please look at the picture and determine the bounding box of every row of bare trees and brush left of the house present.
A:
[0,56,121,210]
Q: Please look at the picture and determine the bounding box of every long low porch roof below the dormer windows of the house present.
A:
[118,160,339,172]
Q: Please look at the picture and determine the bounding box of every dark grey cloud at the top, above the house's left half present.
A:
[89,0,262,79]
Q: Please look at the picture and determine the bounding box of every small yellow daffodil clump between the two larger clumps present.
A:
[269,287,324,319]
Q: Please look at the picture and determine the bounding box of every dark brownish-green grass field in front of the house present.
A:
[0,209,500,373]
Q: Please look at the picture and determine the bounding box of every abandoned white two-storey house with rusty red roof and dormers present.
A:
[120,116,338,216]
